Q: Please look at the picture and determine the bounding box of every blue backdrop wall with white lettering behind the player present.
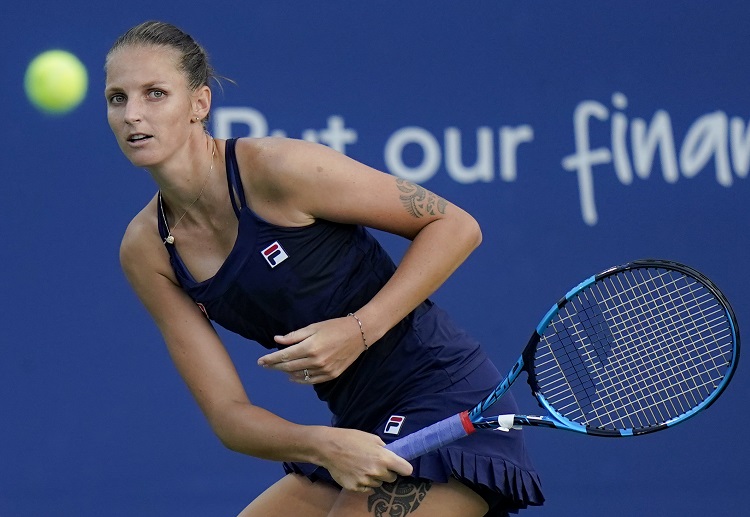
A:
[0,0,750,517]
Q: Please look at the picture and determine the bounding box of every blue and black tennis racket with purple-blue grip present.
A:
[387,260,740,459]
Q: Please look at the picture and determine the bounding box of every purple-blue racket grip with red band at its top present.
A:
[386,411,475,460]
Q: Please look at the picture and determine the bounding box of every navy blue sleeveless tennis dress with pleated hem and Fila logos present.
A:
[158,140,544,517]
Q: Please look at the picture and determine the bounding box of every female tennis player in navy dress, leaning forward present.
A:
[105,22,544,517]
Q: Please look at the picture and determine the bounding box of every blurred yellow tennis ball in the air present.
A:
[24,50,89,114]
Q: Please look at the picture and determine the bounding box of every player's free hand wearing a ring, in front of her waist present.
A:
[258,316,365,384]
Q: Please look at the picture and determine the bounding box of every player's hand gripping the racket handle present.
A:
[312,427,413,492]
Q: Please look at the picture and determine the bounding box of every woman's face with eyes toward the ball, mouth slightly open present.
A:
[104,46,196,167]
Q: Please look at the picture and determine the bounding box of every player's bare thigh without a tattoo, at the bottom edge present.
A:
[237,474,341,517]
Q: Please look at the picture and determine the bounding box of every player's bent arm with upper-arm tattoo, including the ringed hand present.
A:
[259,140,482,382]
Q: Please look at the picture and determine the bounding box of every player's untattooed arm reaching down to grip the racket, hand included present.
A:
[120,213,411,489]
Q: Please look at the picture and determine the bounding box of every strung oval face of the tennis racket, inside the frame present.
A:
[535,269,732,429]
